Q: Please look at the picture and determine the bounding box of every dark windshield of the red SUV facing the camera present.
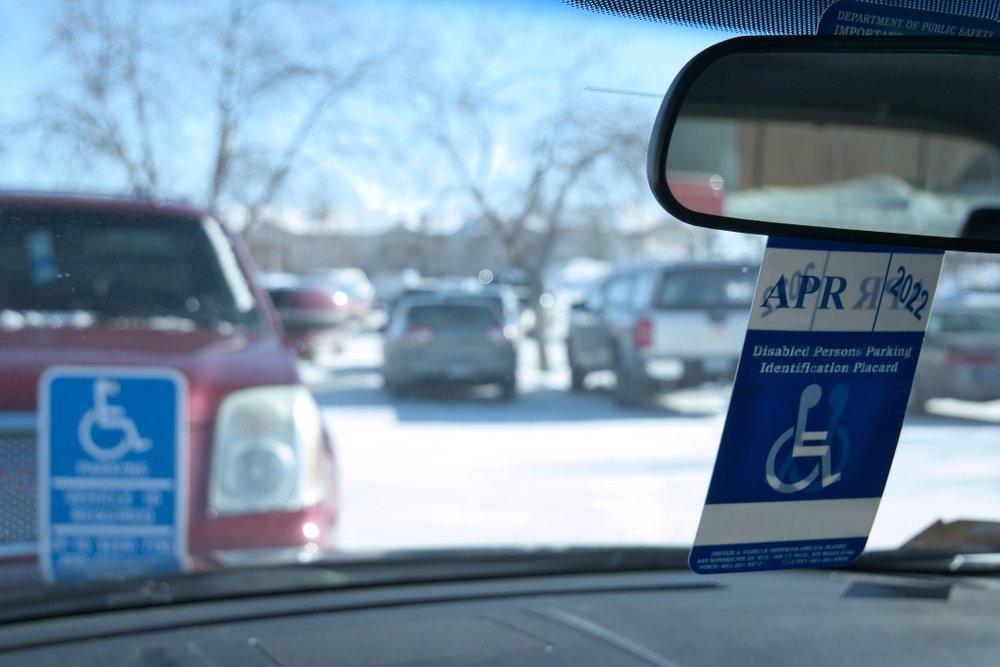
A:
[0,210,261,328]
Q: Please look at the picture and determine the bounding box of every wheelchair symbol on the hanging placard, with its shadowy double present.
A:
[765,384,850,493]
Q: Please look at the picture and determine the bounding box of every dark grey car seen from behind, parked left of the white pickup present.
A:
[383,295,517,399]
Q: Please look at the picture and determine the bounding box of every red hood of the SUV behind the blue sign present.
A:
[0,326,299,424]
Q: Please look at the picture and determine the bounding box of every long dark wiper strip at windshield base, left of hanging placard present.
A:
[0,547,688,624]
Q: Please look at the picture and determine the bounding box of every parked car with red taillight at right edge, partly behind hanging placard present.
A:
[909,301,1000,412]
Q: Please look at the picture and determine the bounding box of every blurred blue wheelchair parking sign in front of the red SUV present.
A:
[38,367,188,581]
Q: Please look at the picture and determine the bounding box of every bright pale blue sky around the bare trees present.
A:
[0,0,724,232]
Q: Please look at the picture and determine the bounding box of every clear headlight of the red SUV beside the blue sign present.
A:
[209,386,326,515]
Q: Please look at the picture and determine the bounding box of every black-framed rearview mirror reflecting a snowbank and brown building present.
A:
[647,37,1000,252]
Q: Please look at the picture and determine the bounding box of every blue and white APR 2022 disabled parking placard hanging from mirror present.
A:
[690,238,944,574]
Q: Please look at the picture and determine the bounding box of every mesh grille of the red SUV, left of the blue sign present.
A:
[0,431,38,555]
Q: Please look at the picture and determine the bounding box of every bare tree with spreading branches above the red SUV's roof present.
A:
[36,0,405,231]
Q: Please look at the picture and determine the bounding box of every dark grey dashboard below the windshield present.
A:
[0,571,1000,667]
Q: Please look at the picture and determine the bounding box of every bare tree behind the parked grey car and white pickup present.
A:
[425,50,649,370]
